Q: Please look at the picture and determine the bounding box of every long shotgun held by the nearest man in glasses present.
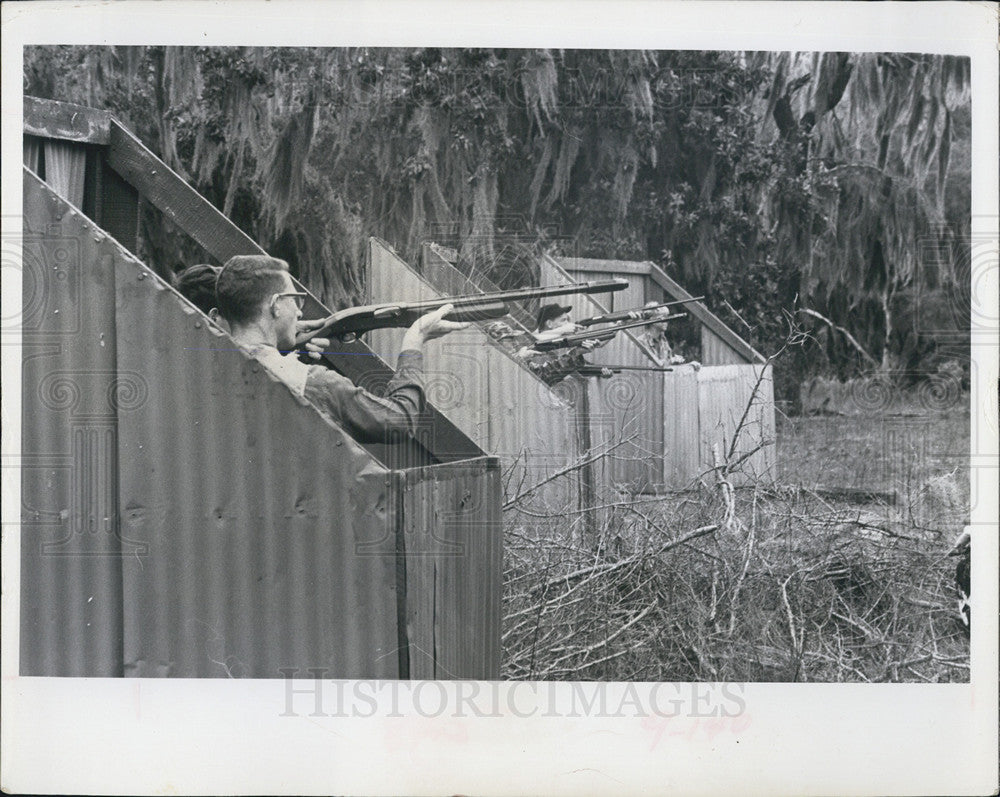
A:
[295,279,628,346]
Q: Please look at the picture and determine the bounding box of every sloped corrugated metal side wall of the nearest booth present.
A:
[22,163,499,677]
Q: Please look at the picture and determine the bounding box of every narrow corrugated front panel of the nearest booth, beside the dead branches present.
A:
[402,459,503,680]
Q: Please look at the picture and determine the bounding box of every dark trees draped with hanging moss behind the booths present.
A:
[25,46,971,388]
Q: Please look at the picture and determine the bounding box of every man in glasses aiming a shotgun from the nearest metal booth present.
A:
[215,255,468,443]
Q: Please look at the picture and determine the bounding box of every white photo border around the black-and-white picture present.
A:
[0,0,1000,795]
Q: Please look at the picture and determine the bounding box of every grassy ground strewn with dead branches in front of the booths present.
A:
[503,409,969,682]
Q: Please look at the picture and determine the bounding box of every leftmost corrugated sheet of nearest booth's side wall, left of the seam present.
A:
[20,171,124,677]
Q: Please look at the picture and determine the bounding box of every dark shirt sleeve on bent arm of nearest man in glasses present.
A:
[305,350,426,443]
